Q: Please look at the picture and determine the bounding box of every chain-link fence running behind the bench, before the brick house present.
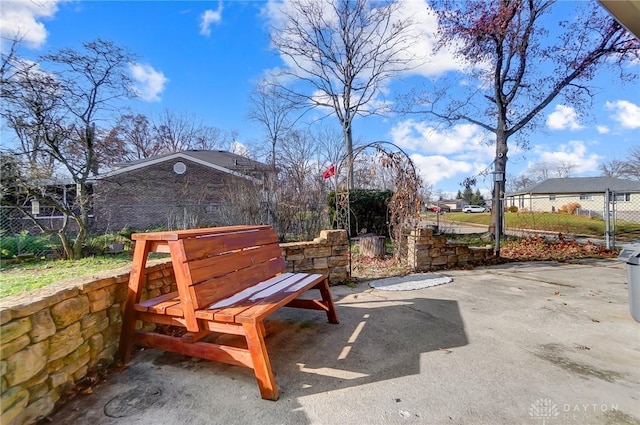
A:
[0,201,330,260]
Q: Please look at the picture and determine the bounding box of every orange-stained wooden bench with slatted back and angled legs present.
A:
[116,226,338,400]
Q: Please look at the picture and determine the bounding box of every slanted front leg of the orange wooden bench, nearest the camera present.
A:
[242,320,278,401]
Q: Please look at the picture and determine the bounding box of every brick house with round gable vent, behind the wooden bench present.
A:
[93,150,272,232]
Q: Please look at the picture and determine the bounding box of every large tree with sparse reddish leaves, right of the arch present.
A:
[410,0,640,255]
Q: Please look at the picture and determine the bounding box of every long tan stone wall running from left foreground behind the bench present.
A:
[0,230,348,425]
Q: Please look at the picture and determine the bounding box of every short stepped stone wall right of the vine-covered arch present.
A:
[407,229,493,271]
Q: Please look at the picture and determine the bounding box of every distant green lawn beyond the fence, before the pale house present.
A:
[440,212,640,240]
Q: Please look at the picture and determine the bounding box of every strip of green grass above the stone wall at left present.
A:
[0,254,131,298]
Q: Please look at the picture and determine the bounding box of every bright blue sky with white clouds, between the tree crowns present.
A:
[0,0,640,192]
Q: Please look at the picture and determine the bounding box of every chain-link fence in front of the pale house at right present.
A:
[504,191,640,248]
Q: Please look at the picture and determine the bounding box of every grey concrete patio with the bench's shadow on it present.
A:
[43,260,640,425]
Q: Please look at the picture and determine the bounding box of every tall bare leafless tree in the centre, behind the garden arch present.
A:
[271,0,413,187]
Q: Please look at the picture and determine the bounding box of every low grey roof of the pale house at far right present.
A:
[507,177,640,196]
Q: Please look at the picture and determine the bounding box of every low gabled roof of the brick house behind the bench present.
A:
[99,150,271,181]
